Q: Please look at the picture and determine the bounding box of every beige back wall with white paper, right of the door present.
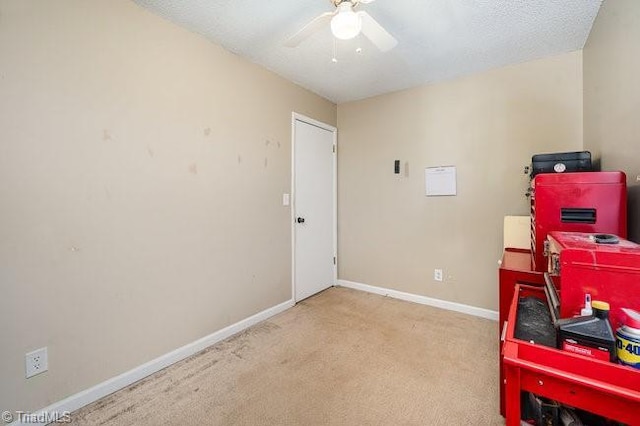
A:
[338,52,582,309]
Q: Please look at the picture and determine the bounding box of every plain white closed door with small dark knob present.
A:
[292,114,336,302]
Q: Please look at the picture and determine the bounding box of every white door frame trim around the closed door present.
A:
[290,111,338,303]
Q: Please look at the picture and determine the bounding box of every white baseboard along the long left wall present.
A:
[11,299,295,426]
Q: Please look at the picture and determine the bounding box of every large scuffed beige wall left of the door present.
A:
[0,0,336,410]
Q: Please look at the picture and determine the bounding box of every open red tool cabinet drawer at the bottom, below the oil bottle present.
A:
[502,285,640,426]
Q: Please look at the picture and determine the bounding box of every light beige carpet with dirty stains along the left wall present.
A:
[72,287,504,426]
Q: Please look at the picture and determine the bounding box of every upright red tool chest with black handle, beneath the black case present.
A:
[531,171,627,272]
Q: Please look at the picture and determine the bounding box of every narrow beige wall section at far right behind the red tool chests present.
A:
[583,0,640,242]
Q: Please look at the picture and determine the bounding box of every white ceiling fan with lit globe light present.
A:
[284,0,398,52]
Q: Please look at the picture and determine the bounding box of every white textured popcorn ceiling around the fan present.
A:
[134,0,602,103]
